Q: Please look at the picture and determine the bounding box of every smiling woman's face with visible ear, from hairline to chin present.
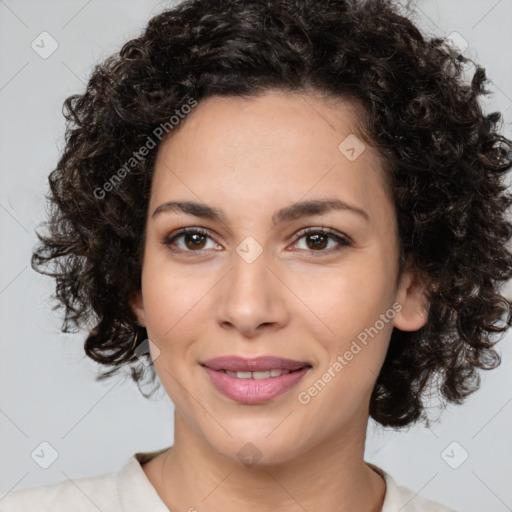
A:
[133,92,426,463]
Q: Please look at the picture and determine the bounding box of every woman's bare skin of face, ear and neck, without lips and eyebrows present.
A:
[132,91,428,512]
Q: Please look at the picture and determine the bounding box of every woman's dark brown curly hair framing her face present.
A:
[32,0,512,428]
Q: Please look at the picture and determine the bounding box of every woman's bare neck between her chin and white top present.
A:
[144,412,386,512]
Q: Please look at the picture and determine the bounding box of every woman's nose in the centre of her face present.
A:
[215,246,290,338]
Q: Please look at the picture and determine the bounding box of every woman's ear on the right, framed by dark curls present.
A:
[393,262,429,331]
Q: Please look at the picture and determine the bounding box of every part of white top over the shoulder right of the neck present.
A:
[366,462,457,512]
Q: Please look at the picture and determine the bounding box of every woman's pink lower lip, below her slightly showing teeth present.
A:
[203,366,310,404]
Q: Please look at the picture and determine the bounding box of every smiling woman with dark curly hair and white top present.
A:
[2,0,512,512]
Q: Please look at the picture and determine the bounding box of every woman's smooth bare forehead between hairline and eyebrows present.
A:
[150,91,390,229]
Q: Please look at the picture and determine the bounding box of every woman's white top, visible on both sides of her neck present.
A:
[0,448,456,512]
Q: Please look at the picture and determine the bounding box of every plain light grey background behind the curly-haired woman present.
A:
[0,0,512,512]
